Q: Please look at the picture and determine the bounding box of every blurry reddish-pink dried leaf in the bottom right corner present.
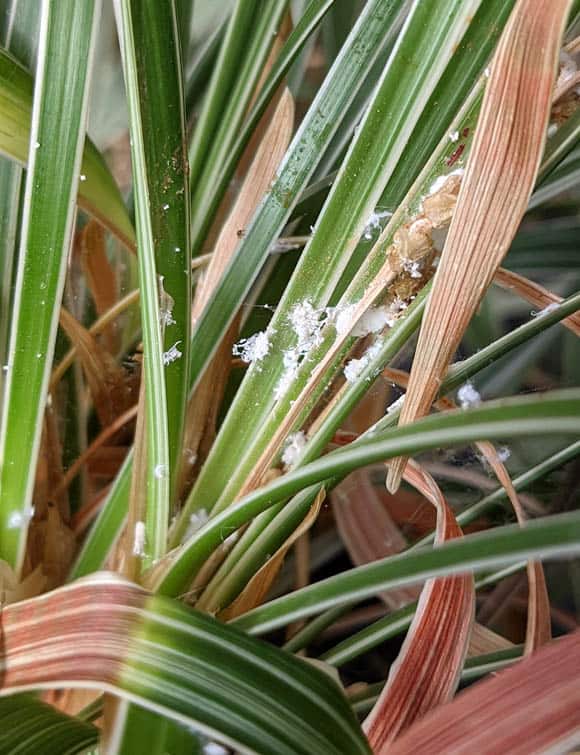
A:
[387,631,580,755]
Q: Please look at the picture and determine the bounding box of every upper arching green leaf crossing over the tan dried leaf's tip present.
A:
[152,390,580,595]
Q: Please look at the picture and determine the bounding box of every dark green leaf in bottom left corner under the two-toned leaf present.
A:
[0,695,99,755]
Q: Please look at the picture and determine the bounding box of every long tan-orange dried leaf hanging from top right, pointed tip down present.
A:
[388,0,571,492]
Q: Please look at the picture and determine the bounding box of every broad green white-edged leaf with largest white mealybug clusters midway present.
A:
[182,0,478,534]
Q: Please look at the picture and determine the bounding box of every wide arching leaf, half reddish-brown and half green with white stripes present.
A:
[2,574,369,755]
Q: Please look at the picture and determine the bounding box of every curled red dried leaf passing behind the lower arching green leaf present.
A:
[364,461,475,754]
